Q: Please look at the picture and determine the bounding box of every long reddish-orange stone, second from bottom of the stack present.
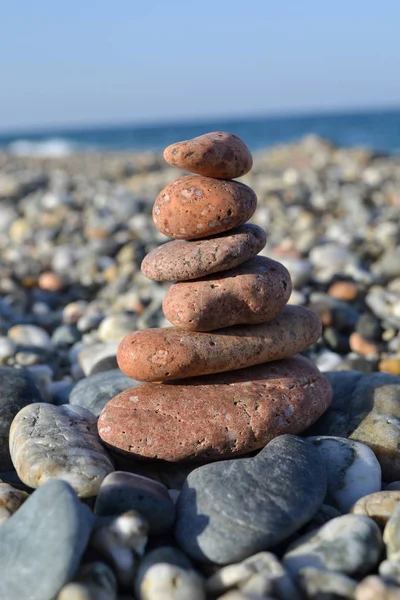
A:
[116,306,322,382]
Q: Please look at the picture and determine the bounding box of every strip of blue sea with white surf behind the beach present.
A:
[0,108,400,156]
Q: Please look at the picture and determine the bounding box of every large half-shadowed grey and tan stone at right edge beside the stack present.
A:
[309,371,400,482]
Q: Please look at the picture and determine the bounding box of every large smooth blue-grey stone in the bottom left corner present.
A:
[0,480,94,600]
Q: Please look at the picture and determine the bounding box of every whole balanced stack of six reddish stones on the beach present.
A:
[98,132,331,462]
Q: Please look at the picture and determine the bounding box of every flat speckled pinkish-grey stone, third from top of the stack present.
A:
[141,224,267,281]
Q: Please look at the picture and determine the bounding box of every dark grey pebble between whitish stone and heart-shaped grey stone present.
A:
[94,471,175,534]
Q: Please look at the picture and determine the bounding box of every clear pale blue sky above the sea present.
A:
[0,0,400,131]
